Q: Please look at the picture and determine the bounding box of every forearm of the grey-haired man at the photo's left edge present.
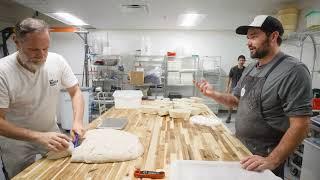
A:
[0,118,39,141]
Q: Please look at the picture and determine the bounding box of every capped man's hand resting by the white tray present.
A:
[240,155,280,171]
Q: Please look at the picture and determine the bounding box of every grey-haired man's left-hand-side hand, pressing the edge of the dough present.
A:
[36,132,71,152]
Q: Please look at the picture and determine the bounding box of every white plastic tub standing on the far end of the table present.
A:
[113,90,143,109]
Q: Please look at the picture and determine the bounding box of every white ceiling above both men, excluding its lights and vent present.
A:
[15,0,298,30]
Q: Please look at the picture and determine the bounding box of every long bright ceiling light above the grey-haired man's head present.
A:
[46,12,89,26]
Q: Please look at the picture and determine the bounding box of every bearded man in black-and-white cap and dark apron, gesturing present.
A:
[196,15,312,178]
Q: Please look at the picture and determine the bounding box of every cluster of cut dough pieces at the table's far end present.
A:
[140,97,208,119]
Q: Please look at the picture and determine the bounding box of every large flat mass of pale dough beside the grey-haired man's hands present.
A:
[71,129,144,163]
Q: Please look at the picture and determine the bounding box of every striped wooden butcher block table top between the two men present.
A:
[13,102,251,180]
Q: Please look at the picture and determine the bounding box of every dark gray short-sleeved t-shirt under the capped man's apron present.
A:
[233,52,312,131]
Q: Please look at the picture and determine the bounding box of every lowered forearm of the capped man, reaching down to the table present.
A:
[267,117,309,164]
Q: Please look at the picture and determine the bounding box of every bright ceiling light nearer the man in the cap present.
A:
[178,13,206,27]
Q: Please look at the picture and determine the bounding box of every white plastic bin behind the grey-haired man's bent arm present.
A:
[60,87,91,130]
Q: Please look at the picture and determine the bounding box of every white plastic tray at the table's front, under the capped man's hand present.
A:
[170,160,281,180]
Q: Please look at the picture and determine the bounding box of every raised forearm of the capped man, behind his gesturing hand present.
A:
[211,91,239,107]
